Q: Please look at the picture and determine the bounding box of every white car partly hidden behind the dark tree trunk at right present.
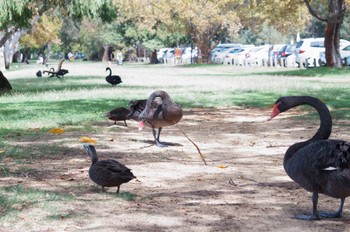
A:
[296,38,349,67]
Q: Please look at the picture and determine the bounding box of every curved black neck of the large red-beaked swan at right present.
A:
[281,96,332,161]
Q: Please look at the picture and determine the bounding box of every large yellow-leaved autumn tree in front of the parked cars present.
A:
[114,0,308,61]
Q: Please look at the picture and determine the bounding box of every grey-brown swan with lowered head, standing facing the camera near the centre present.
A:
[130,90,183,147]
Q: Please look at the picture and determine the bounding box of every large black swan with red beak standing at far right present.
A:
[270,96,350,220]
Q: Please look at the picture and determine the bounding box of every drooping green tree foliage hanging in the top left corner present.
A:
[0,0,114,92]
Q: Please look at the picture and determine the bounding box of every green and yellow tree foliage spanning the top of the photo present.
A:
[0,0,350,67]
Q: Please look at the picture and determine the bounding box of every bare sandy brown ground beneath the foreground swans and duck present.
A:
[0,62,350,232]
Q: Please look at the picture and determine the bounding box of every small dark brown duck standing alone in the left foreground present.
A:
[83,144,136,193]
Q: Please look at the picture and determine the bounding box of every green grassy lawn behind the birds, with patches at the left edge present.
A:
[0,63,350,223]
